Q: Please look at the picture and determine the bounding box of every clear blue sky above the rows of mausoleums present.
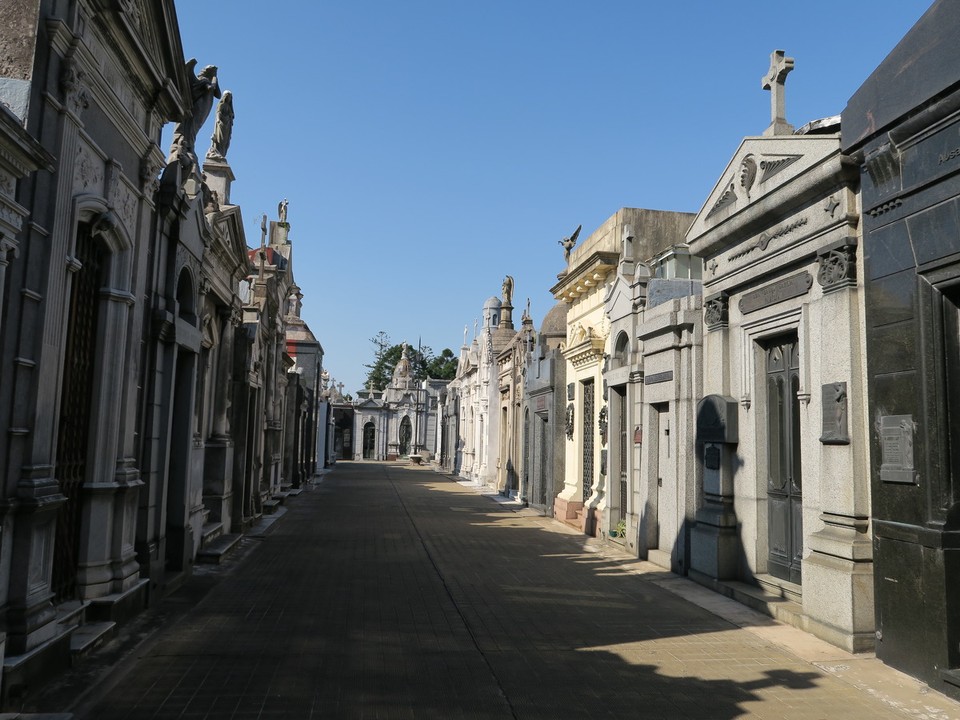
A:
[171,0,930,393]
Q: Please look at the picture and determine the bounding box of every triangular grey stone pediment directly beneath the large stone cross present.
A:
[687,134,840,245]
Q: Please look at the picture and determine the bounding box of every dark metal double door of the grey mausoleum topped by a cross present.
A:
[766,335,803,584]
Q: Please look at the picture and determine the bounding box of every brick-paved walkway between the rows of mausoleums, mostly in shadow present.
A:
[26,463,960,720]
